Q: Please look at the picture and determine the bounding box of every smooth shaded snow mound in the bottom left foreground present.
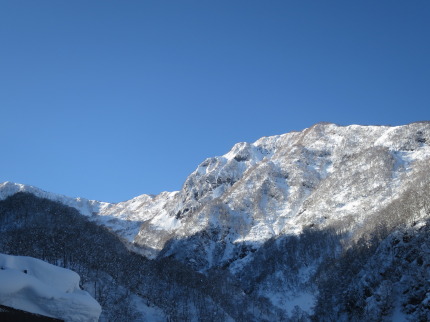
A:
[0,254,101,322]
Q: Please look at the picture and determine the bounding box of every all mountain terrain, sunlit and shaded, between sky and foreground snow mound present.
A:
[0,122,430,321]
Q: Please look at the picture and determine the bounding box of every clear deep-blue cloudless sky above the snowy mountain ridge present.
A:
[0,0,430,202]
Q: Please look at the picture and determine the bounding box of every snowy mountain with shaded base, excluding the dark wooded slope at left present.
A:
[0,122,430,320]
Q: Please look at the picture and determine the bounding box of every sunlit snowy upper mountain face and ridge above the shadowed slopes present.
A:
[0,122,430,270]
